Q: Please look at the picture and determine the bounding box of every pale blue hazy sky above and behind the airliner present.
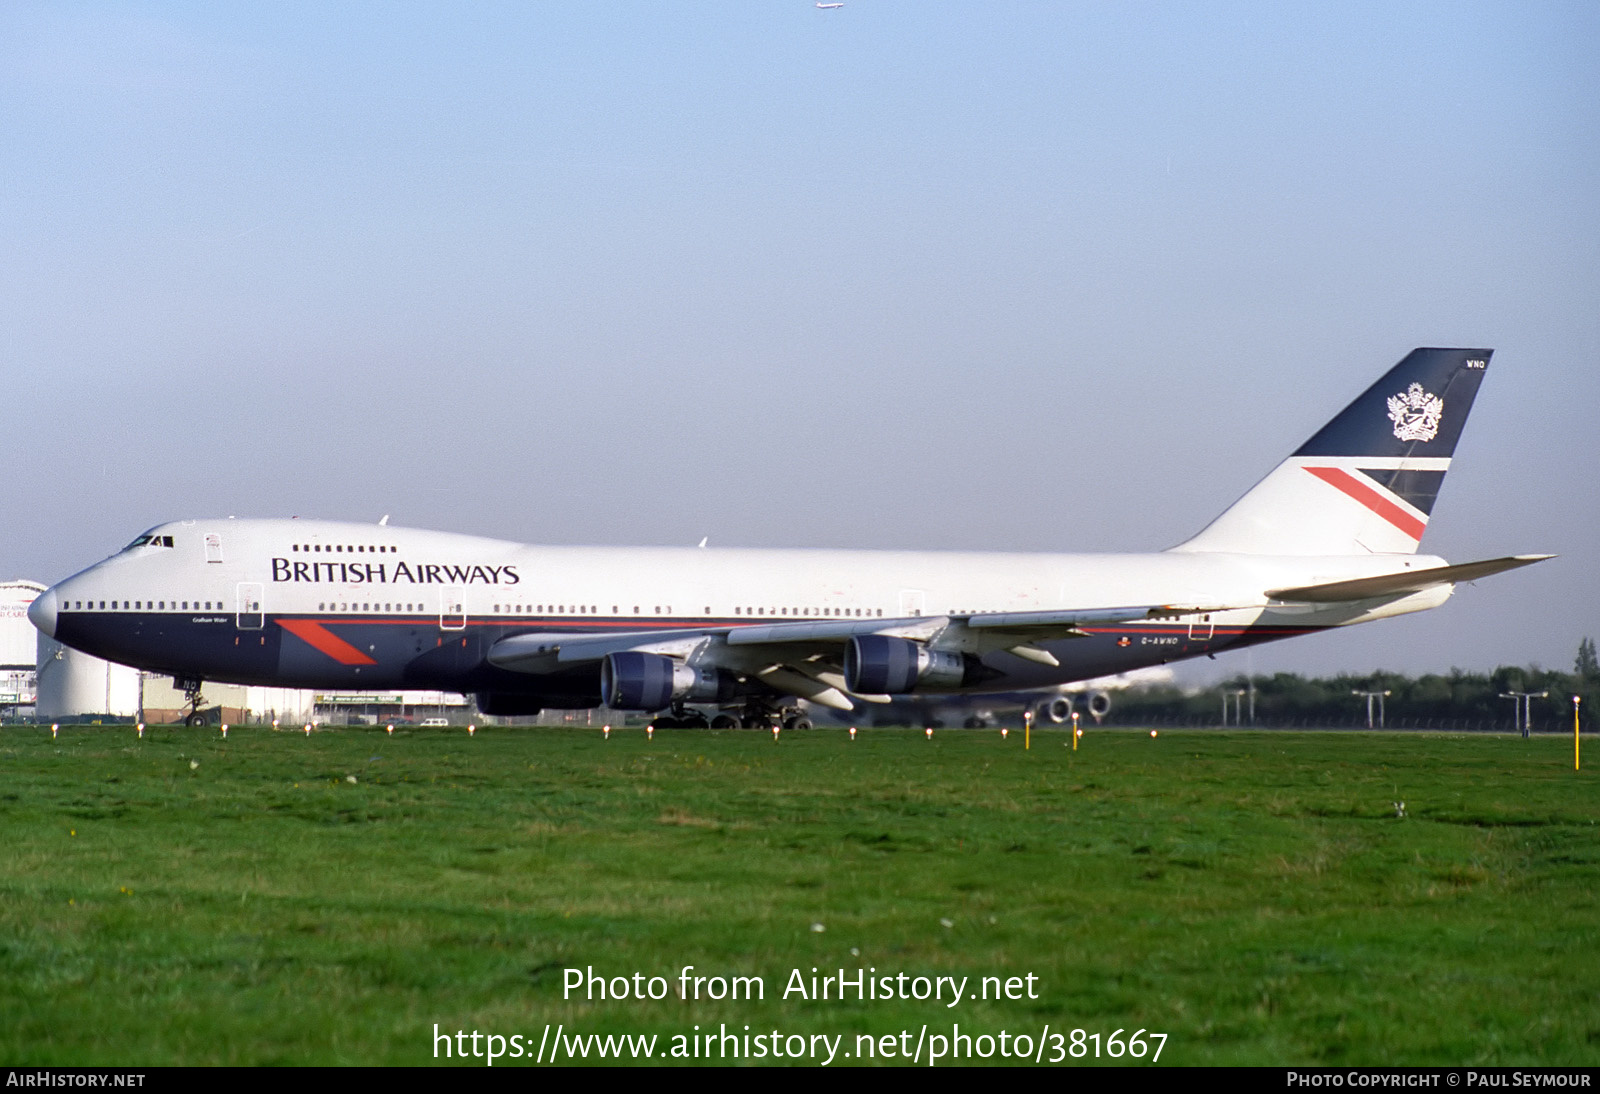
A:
[0,0,1600,678]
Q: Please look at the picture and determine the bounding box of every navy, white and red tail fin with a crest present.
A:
[1173,349,1493,555]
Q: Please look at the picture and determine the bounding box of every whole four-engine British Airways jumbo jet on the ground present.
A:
[29,349,1549,726]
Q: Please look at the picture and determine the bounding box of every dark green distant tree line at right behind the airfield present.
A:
[1106,638,1600,733]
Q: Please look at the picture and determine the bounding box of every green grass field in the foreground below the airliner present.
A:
[0,726,1600,1065]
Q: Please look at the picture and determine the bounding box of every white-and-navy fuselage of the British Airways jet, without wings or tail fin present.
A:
[31,520,1450,705]
